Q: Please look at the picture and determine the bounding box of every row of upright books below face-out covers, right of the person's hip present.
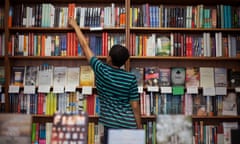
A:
[140,92,240,116]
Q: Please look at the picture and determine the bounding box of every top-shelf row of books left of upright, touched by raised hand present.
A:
[9,3,126,27]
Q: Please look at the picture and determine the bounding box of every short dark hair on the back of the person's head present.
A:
[109,44,129,67]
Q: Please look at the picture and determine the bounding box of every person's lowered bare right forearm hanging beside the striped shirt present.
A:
[131,101,142,129]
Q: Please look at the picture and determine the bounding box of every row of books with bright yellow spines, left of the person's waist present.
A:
[9,91,99,116]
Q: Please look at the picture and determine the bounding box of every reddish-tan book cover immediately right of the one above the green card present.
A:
[185,67,200,87]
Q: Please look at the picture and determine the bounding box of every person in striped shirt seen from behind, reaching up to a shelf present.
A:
[69,17,142,144]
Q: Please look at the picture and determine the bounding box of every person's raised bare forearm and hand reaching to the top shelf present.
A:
[68,17,94,61]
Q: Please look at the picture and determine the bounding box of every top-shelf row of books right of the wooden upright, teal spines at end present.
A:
[130,3,240,28]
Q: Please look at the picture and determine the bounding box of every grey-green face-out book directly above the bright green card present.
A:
[171,67,186,86]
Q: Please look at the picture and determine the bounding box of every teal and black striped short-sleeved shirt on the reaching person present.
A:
[90,57,139,128]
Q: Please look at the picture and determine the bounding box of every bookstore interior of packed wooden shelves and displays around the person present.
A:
[0,0,240,144]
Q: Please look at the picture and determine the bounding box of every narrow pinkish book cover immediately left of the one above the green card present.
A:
[159,68,171,86]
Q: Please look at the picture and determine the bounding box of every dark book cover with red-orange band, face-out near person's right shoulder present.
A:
[144,67,159,86]
